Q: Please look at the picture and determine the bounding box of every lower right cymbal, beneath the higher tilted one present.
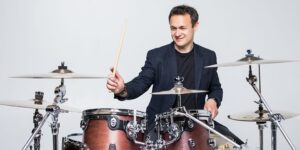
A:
[228,110,299,122]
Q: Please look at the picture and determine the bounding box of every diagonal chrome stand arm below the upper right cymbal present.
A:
[246,65,295,150]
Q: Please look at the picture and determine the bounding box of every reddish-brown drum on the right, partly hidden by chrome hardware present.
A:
[156,108,213,150]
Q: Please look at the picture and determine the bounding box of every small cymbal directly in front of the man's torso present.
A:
[151,87,207,95]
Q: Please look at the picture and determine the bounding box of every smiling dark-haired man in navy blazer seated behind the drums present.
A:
[106,5,243,145]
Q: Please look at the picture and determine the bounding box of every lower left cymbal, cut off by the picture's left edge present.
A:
[0,99,82,113]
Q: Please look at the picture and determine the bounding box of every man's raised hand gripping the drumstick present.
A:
[106,71,125,94]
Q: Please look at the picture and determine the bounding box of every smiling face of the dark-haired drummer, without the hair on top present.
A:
[170,14,198,52]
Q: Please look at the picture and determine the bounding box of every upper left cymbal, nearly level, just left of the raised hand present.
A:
[11,63,107,79]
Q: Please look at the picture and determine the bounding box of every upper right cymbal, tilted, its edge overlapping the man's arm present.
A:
[205,50,297,68]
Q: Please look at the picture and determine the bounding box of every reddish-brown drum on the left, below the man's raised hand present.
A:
[81,108,146,150]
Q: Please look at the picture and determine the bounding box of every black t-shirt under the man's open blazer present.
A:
[173,48,197,109]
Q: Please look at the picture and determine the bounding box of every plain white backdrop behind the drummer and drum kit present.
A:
[0,0,300,150]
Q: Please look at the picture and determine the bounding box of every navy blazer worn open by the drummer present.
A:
[117,42,223,128]
